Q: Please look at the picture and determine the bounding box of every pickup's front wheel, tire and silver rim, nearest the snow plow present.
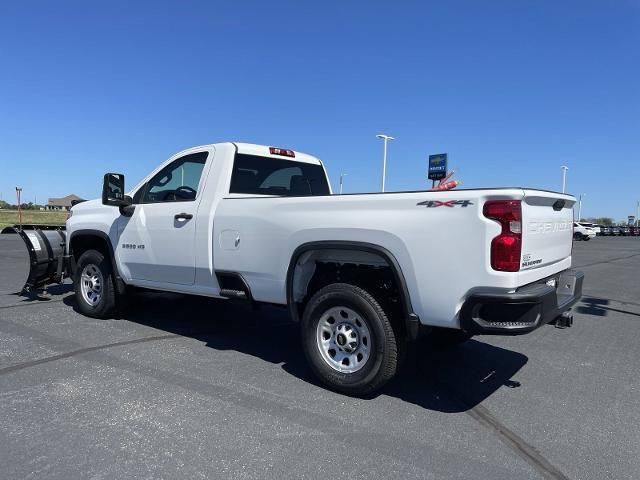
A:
[73,250,117,318]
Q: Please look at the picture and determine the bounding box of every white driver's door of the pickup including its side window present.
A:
[116,151,213,285]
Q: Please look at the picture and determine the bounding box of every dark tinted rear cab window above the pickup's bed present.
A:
[229,153,329,197]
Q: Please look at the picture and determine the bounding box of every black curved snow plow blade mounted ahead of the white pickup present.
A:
[2,225,67,294]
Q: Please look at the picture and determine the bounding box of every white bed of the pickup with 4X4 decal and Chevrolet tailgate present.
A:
[213,188,575,327]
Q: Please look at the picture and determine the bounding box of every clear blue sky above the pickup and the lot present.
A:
[0,0,640,220]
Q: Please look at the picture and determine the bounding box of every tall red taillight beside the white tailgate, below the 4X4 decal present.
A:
[483,200,522,272]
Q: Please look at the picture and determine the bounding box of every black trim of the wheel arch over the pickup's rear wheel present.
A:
[286,240,420,339]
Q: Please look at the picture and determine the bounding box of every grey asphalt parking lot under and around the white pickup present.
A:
[0,235,640,479]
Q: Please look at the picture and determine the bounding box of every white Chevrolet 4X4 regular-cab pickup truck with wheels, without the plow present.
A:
[21,143,583,395]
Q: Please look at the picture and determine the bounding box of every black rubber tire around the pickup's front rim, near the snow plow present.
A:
[73,250,118,318]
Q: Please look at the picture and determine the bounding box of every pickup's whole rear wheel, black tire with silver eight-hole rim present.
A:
[301,283,398,395]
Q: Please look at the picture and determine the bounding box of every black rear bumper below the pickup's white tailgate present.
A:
[460,270,584,335]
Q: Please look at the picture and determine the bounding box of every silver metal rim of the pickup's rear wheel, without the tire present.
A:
[316,307,372,373]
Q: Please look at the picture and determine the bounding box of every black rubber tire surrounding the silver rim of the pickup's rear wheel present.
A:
[301,283,398,396]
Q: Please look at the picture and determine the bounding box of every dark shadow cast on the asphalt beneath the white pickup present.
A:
[64,292,528,413]
